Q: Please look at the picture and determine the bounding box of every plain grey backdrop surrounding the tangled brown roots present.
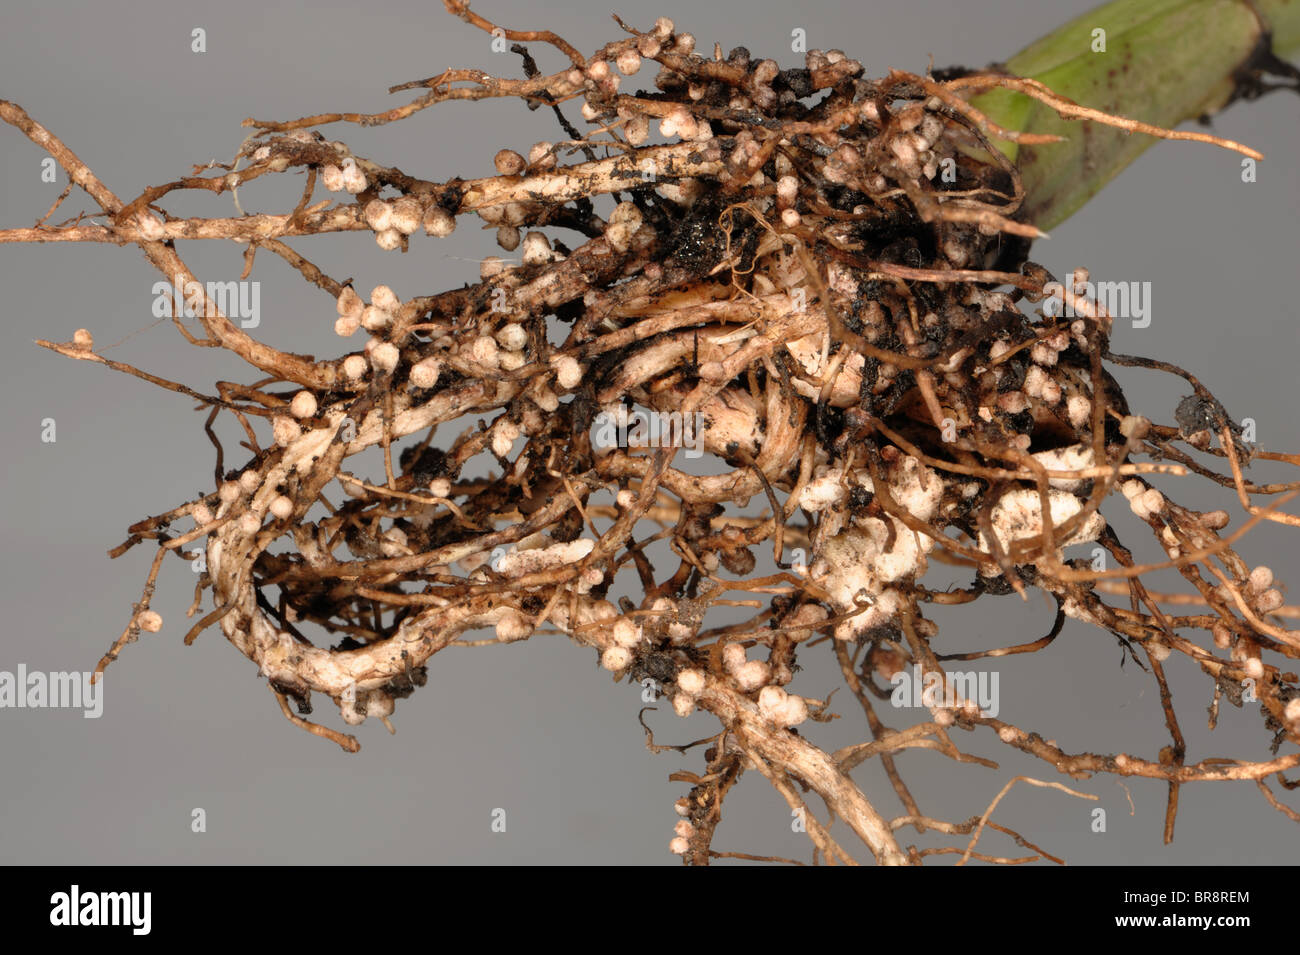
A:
[0,0,1300,878]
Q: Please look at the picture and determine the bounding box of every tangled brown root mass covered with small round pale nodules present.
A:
[48,4,1300,863]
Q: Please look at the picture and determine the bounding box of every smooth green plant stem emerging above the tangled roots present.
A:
[971,0,1300,230]
